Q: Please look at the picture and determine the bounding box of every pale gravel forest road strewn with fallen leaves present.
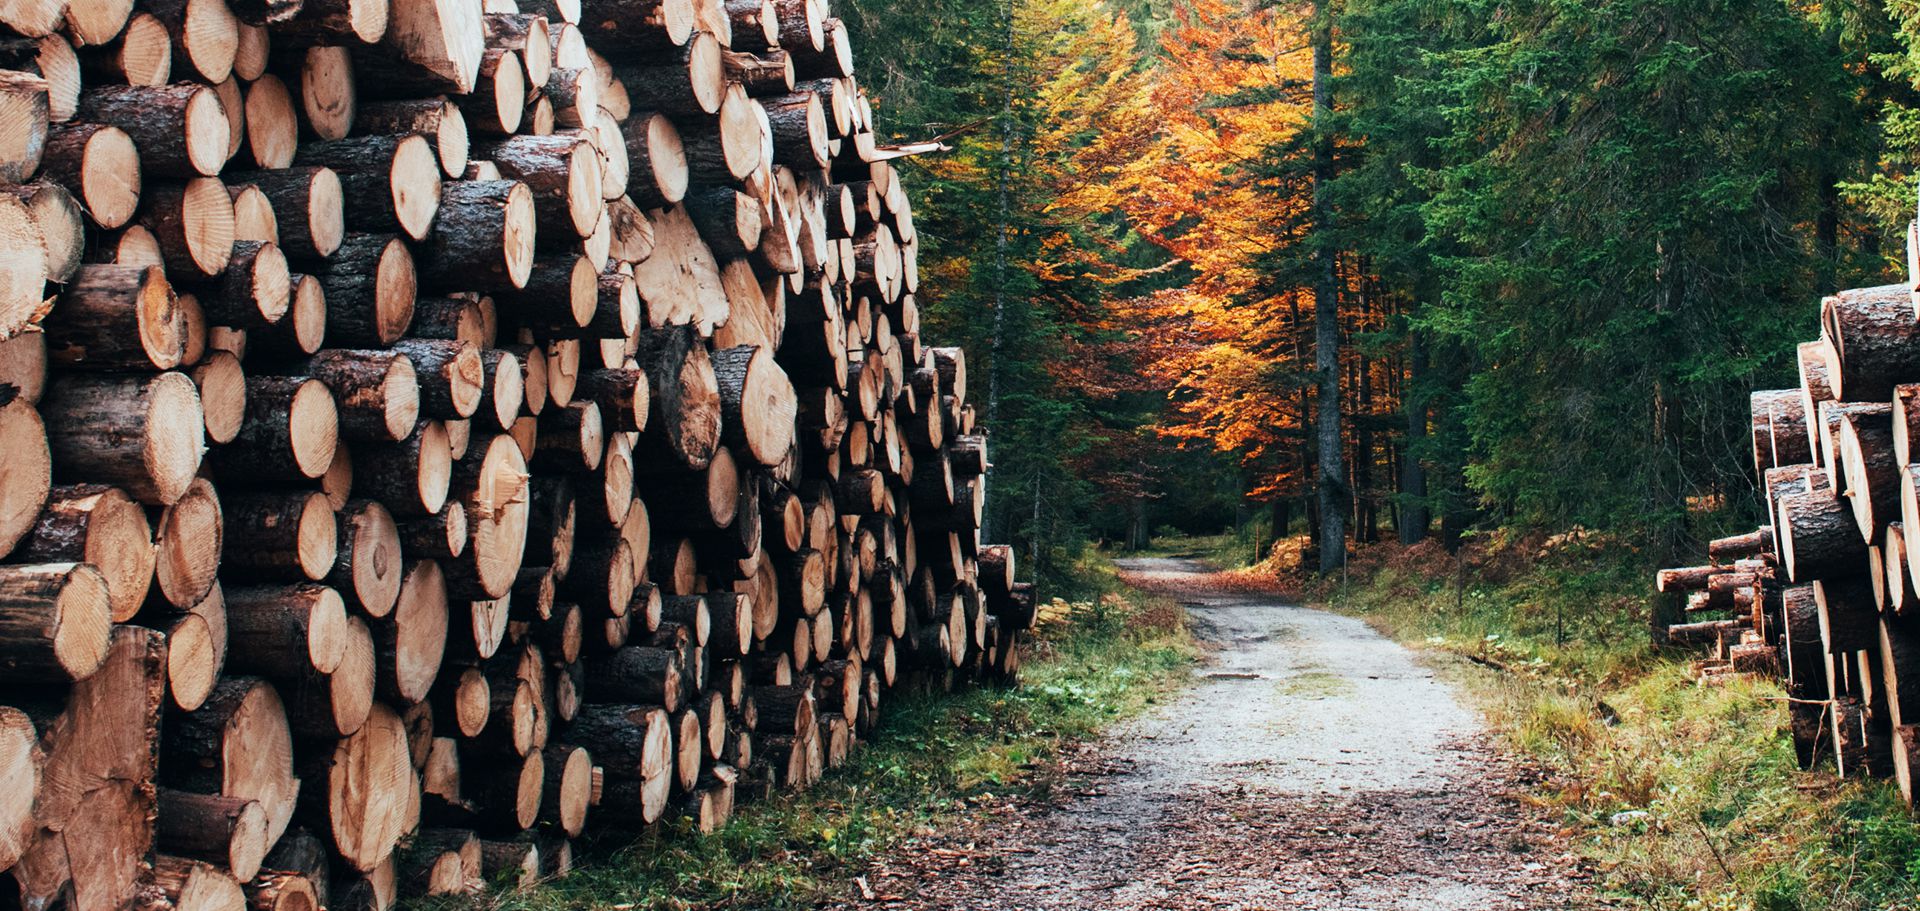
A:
[845,559,1599,911]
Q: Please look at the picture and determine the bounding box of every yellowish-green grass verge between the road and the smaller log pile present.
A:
[1311,536,1920,911]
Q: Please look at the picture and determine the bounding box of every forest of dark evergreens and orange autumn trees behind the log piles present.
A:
[839,0,1920,575]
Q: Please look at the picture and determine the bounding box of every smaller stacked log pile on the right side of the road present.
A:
[1657,221,1920,801]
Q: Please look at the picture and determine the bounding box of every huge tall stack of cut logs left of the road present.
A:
[0,0,1033,911]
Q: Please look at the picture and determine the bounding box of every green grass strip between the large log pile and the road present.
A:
[456,594,1194,911]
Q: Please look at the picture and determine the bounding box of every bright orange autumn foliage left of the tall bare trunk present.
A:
[1117,0,1311,496]
